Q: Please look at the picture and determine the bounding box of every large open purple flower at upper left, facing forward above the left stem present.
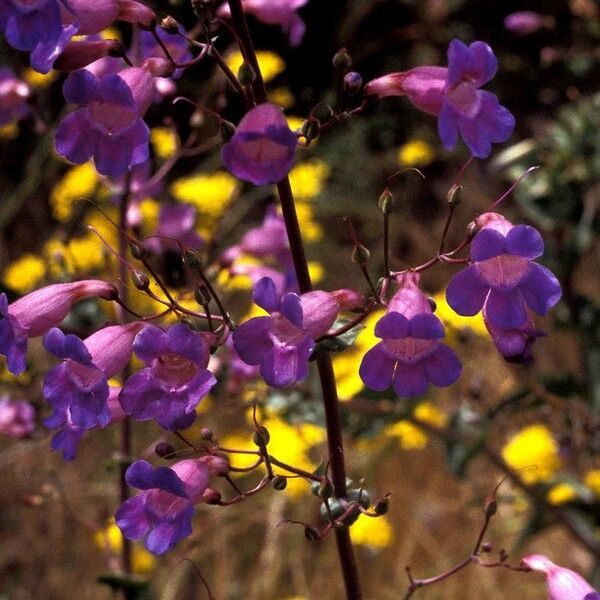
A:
[55,67,153,177]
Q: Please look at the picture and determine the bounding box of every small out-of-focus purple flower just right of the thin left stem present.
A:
[144,204,204,254]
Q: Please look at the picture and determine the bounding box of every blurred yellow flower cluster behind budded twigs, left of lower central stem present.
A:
[220,416,325,498]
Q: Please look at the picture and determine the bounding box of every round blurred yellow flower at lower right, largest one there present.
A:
[502,423,561,484]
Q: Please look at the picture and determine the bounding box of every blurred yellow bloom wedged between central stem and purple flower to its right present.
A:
[332,310,384,400]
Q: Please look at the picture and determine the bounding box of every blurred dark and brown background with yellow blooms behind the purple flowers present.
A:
[0,0,600,600]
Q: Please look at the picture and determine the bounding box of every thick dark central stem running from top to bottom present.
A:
[227,0,362,600]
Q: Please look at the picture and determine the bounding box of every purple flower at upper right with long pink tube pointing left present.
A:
[365,40,515,158]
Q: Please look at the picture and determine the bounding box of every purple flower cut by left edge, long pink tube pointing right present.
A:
[0,279,117,375]
